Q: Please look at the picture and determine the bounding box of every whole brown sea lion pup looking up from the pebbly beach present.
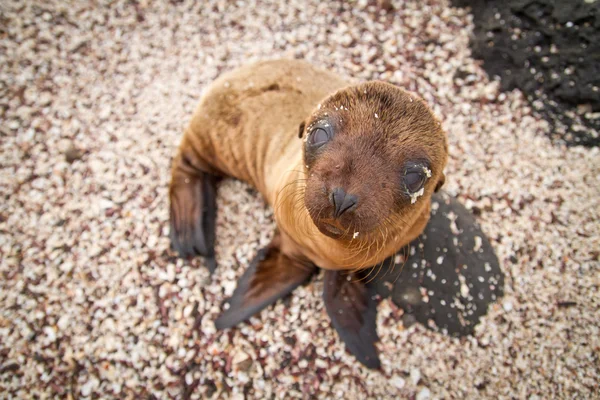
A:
[169,60,447,368]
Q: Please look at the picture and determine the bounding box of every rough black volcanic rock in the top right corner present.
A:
[453,0,600,146]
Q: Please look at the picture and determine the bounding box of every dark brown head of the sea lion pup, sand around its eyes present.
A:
[300,81,447,241]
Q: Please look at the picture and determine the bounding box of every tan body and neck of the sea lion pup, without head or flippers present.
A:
[174,60,445,270]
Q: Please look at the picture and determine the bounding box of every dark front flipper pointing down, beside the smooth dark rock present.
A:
[323,270,381,369]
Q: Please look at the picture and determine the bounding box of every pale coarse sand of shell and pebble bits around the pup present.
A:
[0,0,600,400]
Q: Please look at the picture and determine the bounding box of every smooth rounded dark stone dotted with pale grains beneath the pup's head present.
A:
[368,192,504,337]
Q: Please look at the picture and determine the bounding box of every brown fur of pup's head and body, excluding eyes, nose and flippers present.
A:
[170,60,447,269]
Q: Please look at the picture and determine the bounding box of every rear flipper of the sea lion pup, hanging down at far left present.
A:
[169,154,219,273]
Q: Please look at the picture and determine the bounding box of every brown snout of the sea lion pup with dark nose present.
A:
[304,133,395,240]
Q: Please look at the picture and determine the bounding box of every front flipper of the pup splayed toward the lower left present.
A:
[215,236,317,329]
